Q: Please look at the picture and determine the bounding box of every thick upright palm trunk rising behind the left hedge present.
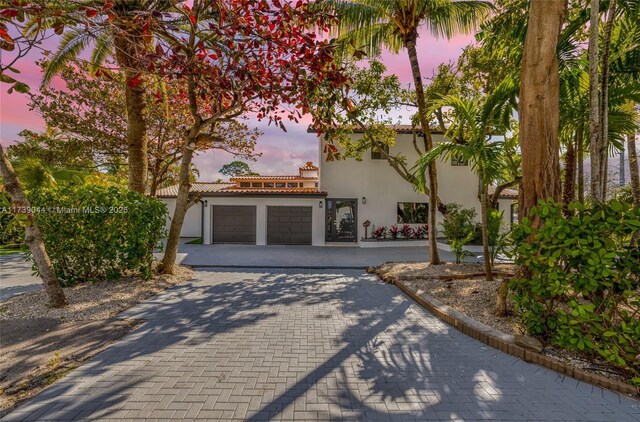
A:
[114,34,148,194]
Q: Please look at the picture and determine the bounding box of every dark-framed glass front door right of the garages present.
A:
[325,199,358,242]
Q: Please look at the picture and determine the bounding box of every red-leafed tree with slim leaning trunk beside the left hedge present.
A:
[130,0,346,273]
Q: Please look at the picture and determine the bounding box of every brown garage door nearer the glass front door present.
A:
[267,207,312,245]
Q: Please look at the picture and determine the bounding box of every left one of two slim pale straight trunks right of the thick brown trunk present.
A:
[589,0,603,202]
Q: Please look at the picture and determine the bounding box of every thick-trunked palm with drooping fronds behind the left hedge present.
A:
[37,0,174,194]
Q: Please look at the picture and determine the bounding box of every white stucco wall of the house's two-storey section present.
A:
[319,134,511,239]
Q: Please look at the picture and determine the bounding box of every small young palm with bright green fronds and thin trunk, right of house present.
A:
[415,85,514,281]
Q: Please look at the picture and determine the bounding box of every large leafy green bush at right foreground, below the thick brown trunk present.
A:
[511,200,640,384]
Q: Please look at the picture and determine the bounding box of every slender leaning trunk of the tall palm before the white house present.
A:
[405,38,440,265]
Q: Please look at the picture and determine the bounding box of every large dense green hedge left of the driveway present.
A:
[29,185,166,285]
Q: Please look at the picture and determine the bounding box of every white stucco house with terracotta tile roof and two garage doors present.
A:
[158,126,517,246]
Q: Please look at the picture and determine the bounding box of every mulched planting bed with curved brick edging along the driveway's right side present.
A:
[373,263,640,398]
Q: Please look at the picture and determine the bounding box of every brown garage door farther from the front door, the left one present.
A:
[213,205,256,245]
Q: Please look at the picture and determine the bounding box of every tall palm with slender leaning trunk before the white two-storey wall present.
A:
[323,0,492,264]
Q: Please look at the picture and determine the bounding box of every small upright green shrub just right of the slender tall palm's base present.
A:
[441,203,476,264]
